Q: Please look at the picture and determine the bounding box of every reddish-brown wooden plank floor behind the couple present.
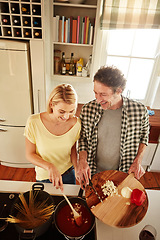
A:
[0,165,160,190]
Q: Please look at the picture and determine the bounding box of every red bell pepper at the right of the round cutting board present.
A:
[131,188,146,206]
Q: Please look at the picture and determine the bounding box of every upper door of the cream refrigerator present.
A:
[0,43,32,126]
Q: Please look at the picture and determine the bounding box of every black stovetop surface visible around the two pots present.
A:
[0,193,96,240]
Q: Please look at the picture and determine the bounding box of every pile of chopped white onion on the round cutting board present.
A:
[101,180,118,197]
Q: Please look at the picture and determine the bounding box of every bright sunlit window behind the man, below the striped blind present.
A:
[101,29,160,104]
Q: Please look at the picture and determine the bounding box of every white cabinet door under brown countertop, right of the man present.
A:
[142,143,157,166]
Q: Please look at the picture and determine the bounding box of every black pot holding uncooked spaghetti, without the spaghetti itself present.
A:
[11,183,54,239]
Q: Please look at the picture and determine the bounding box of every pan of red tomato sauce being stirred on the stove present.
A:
[54,189,95,240]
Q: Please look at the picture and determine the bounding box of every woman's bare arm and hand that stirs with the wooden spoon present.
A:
[26,138,63,191]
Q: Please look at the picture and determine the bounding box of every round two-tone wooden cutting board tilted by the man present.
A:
[85,170,148,228]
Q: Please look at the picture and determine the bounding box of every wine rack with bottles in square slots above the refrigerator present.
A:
[0,0,43,39]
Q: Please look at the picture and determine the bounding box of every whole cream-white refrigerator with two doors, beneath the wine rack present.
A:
[0,39,33,167]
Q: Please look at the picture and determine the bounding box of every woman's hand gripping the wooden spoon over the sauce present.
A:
[47,163,63,192]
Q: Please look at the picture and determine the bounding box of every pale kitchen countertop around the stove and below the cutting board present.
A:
[0,180,160,240]
